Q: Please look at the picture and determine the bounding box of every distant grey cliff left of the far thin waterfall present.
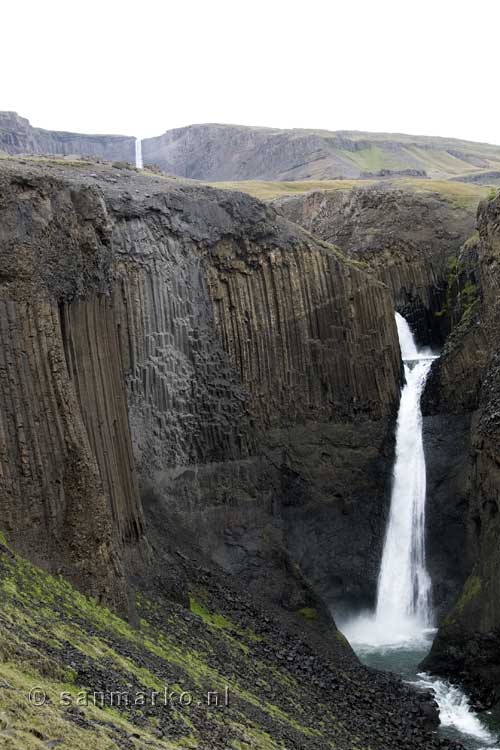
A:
[0,112,135,163]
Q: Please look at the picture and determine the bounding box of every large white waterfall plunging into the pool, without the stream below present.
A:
[344,313,434,644]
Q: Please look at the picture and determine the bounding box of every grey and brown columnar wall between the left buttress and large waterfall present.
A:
[104,179,400,609]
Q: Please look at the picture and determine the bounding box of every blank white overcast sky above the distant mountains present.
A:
[0,0,500,144]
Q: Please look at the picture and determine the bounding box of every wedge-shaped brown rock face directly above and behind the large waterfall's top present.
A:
[273,185,475,345]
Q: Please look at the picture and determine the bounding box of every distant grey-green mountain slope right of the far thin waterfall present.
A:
[139,124,500,181]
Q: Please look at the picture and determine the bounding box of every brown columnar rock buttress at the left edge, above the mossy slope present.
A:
[0,171,138,606]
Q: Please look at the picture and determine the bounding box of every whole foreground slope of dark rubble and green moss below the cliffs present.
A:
[0,546,446,750]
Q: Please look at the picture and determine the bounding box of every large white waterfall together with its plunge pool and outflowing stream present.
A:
[341,313,500,750]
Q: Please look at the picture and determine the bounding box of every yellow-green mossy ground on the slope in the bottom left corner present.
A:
[0,554,347,750]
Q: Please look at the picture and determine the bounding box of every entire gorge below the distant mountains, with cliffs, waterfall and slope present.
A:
[0,121,500,750]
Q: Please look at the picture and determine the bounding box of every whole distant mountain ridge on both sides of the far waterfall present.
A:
[0,112,500,184]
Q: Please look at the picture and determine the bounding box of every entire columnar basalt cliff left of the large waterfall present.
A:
[0,160,400,624]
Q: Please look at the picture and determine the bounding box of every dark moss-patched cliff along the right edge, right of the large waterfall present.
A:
[426,191,500,705]
